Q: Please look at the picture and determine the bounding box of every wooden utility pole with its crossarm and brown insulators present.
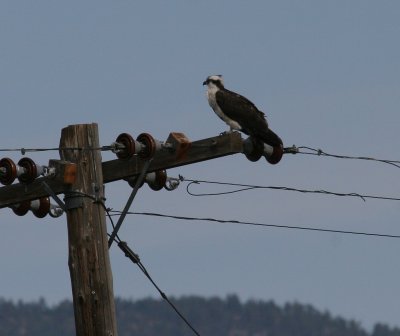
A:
[0,124,283,336]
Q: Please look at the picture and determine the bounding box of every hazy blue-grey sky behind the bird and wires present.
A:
[0,0,400,328]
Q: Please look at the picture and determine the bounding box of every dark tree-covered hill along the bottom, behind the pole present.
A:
[0,295,400,336]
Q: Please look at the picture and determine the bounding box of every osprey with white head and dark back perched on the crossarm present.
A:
[203,75,283,147]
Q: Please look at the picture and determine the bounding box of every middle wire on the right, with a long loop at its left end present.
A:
[179,176,400,201]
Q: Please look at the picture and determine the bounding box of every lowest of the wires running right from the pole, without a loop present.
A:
[110,210,400,238]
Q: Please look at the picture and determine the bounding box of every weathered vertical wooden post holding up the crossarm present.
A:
[60,124,117,336]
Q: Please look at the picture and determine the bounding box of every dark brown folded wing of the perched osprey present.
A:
[215,89,282,146]
